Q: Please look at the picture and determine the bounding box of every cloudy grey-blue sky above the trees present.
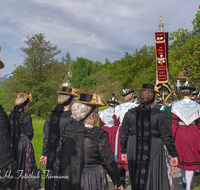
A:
[0,0,200,75]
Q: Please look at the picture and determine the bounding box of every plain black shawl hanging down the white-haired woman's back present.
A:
[60,121,85,190]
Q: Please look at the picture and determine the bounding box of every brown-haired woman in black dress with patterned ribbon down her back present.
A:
[120,84,178,190]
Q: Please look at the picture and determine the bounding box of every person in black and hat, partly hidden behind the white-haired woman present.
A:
[40,87,78,190]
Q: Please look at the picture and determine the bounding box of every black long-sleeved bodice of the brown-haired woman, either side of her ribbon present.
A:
[120,108,177,157]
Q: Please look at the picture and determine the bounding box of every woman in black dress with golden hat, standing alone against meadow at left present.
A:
[9,92,37,190]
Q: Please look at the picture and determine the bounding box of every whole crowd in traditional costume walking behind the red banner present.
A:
[0,64,200,190]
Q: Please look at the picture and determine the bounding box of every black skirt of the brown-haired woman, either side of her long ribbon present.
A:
[127,135,172,190]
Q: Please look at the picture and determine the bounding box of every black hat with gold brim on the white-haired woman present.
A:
[74,94,104,106]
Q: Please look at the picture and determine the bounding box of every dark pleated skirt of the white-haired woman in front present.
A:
[81,165,108,190]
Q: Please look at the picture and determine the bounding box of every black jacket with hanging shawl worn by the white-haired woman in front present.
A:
[54,122,121,190]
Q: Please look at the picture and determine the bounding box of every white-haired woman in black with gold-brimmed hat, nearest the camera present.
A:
[54,94,123,190]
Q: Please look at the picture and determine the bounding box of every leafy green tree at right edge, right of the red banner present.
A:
[169,6,200,84]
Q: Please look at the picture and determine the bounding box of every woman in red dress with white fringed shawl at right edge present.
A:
[172,81,200,190]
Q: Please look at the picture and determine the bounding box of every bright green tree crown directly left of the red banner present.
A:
[115,46,156,94]
